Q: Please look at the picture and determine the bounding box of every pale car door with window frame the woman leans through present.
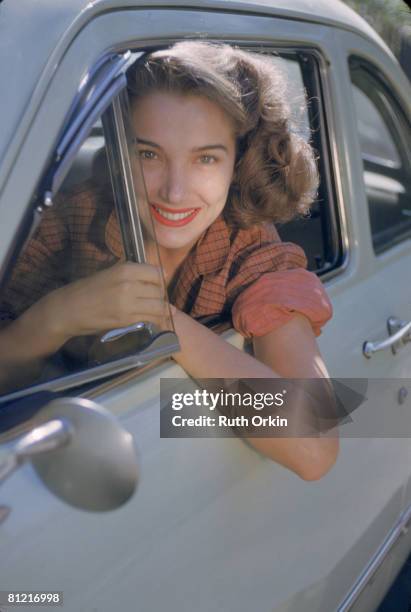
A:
[0,9,410,611]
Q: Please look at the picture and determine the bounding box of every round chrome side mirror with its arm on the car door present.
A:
[0,397,138,512]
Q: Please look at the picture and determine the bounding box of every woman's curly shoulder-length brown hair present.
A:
[128,41,318,228]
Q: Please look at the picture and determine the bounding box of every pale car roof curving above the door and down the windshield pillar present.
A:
[0,0,387,176]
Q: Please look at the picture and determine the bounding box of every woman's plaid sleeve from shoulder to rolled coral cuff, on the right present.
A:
[227,224,332,338]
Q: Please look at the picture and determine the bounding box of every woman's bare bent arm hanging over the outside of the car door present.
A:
[173,309,338,480]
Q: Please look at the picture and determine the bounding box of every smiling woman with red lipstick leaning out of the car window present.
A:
[0,42,338,480]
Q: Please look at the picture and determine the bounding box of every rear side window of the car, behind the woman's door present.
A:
[350,58,411,253]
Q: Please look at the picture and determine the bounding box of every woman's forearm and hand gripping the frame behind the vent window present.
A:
[0,262,165,393]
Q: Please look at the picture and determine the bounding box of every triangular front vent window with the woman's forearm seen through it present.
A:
[0,110,172,397]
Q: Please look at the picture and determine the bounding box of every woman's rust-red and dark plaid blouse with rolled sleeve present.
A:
[0,182,332,338]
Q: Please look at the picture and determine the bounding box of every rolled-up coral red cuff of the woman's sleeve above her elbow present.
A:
[232,268,332,338]
